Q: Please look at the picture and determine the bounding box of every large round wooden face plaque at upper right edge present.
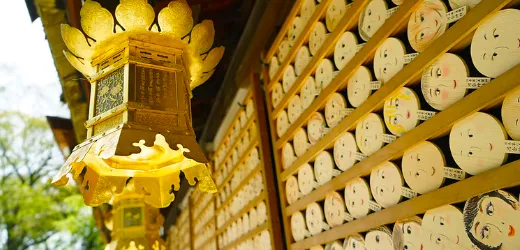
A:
[471,9,520,78]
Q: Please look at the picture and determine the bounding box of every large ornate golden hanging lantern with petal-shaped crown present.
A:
[53,0,224,207]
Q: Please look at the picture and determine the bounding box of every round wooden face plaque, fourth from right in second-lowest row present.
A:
[370,162,403,207]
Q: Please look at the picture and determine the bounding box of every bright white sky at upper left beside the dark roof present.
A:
[0,0,70,118]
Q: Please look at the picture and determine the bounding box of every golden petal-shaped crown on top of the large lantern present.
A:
[61,0,224,89]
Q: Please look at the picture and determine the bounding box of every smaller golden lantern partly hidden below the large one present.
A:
[105,181,166,250]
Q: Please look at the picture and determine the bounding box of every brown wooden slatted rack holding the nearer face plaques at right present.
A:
[263,0,520,249]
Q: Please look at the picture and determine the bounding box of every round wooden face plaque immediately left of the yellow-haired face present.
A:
[356,113,385,155]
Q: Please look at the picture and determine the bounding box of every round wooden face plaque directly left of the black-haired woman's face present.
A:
[422,205,472,250]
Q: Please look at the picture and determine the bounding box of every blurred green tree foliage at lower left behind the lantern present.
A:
[0,112,103,250]
